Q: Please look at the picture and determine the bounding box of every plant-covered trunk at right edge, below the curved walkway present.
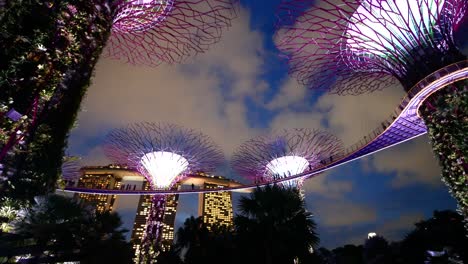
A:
[420,81,468,229]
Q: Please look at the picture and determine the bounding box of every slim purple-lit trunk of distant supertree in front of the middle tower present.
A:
[138,195,166,263]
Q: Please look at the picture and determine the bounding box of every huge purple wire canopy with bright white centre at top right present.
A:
[276,0,468,94]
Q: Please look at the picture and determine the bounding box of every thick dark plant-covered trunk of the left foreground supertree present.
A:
[0,0,112,199]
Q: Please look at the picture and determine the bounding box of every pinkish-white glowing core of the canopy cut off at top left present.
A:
[112,0,174,33]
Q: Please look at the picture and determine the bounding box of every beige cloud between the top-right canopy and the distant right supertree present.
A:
[268,81,404,146]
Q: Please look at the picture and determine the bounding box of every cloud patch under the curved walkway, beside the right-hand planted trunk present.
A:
[363,136,441,188]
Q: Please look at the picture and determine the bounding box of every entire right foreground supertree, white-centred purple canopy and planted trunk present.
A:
[277,0,468,223]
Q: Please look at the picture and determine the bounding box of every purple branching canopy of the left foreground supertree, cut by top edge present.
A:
[104,0,238,66]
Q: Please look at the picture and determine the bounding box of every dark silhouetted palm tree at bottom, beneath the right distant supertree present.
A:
[234,185,319,264]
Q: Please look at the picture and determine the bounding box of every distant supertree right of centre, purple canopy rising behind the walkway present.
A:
[231,128,344,188]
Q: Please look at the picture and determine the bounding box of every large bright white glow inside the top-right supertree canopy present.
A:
[345,0,445,56]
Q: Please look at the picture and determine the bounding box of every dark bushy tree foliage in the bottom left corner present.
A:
[0,195,132,263]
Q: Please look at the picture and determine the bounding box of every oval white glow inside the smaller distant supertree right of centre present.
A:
[266,156,309,183]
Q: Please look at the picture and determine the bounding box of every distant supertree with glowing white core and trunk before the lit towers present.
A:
[104,123,224,263]
